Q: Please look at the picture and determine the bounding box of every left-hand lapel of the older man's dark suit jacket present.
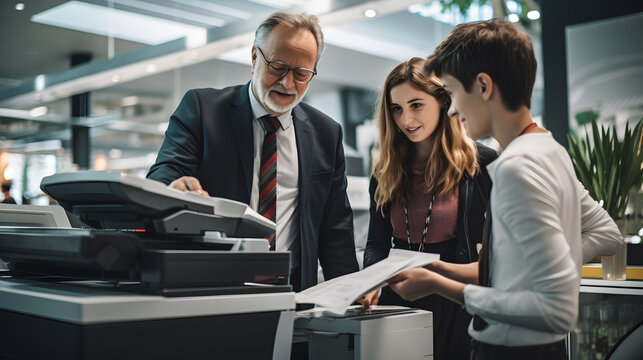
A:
[228,83,254,202]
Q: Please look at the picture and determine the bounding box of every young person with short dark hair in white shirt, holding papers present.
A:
[389,19,622,360]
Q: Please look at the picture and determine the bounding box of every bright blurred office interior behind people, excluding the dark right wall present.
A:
[0,0,543,207]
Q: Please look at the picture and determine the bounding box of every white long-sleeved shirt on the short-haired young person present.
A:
[464,133,622,346]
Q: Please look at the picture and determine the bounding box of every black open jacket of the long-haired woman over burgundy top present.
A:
[364,143,498,266]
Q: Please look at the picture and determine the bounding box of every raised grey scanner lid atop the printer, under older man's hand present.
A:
[40,171,276,237]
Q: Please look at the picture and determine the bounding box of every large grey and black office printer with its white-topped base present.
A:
[0,172,295,360]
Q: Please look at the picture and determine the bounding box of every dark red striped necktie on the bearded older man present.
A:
[259,115,280,247]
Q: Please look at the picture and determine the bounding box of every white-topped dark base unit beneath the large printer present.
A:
[0,278,295,359]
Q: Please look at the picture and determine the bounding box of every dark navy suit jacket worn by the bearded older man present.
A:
[147,84,358,289]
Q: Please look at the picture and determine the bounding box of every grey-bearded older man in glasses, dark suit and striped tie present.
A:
[147,12,358,291]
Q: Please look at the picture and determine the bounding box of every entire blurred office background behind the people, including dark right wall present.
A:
[0,0,643,217]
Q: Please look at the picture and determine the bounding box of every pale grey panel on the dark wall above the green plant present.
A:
[566,13,643,129]
